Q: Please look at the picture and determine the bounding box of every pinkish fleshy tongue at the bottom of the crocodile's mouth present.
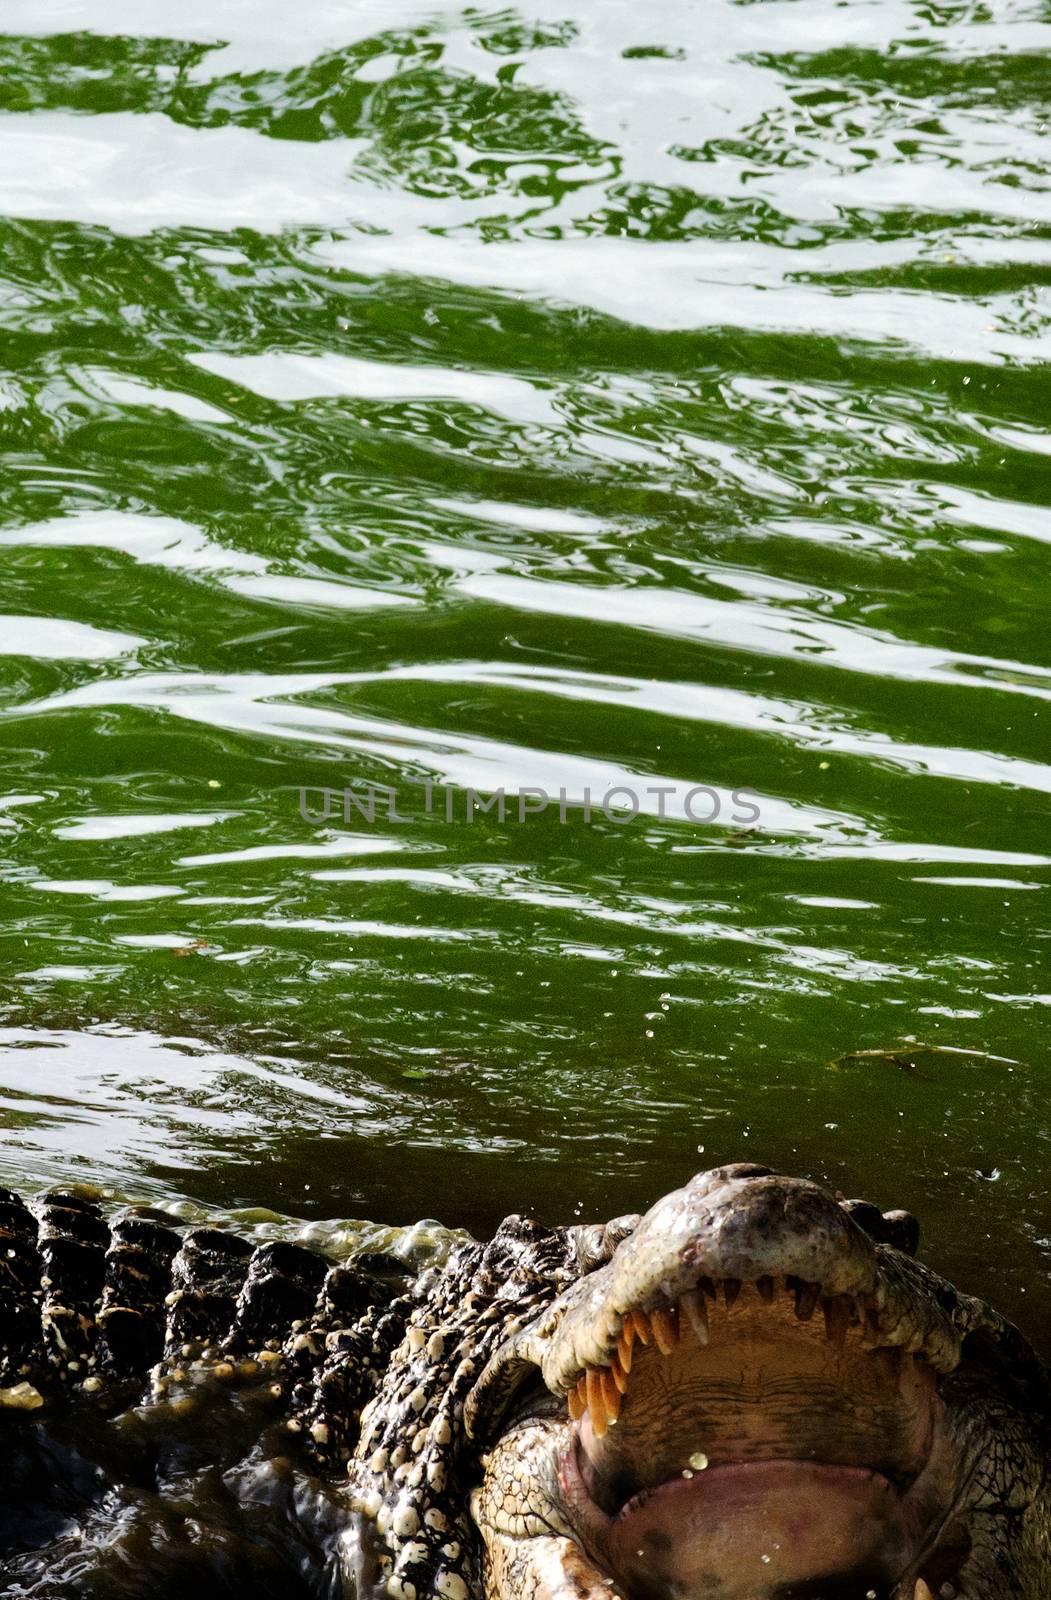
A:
[605,1461,896,1600]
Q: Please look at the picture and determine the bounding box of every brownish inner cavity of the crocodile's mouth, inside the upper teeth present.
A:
[560,1291,955,1600]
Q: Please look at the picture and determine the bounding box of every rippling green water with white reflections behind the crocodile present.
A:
[0,0,1051,1346]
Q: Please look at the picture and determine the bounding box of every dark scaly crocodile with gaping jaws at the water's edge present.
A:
[0,1163,1051,1600]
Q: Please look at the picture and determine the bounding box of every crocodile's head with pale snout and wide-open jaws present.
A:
[469,1165,1051,1600]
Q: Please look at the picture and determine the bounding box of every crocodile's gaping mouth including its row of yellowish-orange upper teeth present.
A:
[543,1171,955,1600]
